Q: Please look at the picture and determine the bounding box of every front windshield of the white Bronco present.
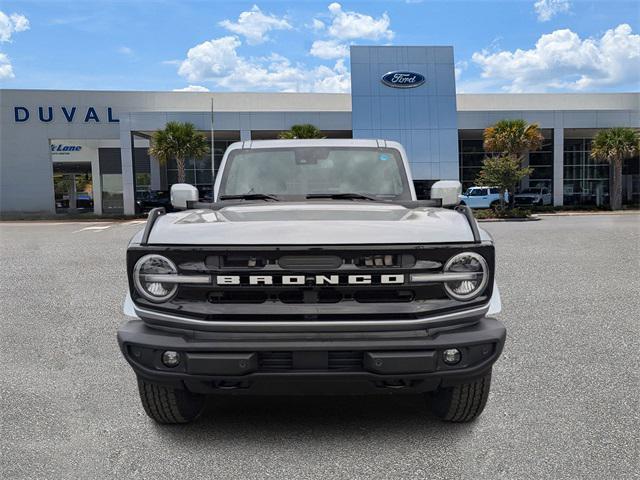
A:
[219,147,411,200]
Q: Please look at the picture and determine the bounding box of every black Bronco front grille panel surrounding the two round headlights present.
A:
[128,244,494,321]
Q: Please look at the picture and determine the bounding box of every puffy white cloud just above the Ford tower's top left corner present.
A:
[328,2,394,40]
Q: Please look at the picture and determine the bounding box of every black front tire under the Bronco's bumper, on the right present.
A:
[431,372,491,422]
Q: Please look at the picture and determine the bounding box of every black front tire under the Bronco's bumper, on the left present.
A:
[138,377,204,424]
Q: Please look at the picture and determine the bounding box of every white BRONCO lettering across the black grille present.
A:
[216,274,404,285]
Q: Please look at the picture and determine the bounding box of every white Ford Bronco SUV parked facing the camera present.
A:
[118,140,506,423]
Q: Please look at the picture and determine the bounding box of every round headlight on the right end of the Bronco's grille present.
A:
[444,252,489,302]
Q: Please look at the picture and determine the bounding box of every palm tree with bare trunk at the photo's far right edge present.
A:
[590,127,640,210]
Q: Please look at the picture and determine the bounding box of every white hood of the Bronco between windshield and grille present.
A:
[144,201,480,245]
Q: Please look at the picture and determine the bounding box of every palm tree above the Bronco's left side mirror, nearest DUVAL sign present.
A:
[149,122,209,183]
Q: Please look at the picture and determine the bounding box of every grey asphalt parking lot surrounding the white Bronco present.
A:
[0,215,640,479]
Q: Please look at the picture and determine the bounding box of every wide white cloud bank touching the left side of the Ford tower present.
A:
[178,37,350,92]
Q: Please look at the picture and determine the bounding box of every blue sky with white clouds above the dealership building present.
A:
[0,0,640,93]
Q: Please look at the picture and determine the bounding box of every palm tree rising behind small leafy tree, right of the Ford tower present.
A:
[482,119,544,206]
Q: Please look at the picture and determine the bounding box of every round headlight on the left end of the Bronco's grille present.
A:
[133,254,178,302]
